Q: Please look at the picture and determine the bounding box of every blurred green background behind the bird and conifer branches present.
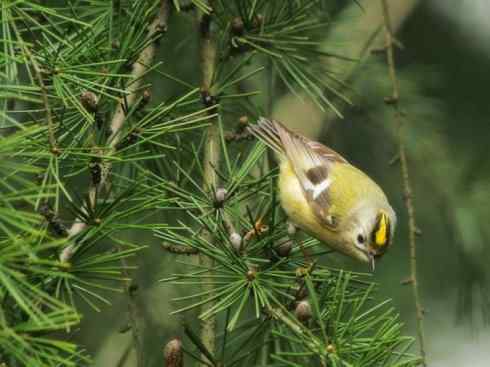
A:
[72,0,490,367]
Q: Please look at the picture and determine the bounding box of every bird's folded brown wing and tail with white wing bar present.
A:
[249,118,347,229]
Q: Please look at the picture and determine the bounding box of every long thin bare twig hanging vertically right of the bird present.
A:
[381,0,426,366]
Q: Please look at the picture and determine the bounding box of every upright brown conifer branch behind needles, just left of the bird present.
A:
[199,3,220,366]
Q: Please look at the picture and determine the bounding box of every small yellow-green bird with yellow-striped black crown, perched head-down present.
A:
[248,117,396,270]
